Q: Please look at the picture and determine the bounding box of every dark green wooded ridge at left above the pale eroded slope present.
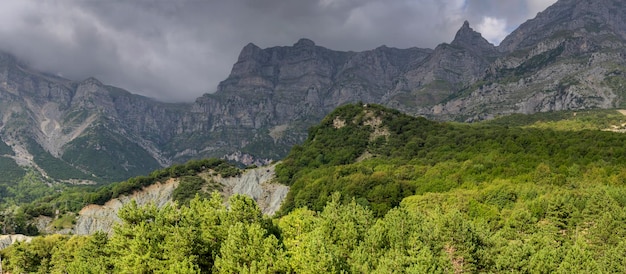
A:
[0,159,241,235]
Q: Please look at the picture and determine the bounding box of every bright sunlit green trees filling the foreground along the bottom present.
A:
[0,185,626,273]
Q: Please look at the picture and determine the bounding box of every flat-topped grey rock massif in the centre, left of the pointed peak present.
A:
[180,39,430,164]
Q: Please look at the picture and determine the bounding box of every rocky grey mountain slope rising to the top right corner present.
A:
[423,0,626,121]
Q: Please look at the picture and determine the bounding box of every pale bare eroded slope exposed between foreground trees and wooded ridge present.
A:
[71,166,289,235]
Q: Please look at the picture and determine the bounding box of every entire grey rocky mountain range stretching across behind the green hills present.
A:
[0,0,626,183]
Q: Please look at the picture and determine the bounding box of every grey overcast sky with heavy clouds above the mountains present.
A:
[0,0,556,102]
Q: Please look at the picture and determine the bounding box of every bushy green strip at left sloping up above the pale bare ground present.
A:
[6,157,241,232]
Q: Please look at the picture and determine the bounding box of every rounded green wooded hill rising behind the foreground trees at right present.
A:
[277,104,626,216]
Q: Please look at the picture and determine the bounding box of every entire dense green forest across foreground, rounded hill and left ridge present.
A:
[0,104,626,273]
